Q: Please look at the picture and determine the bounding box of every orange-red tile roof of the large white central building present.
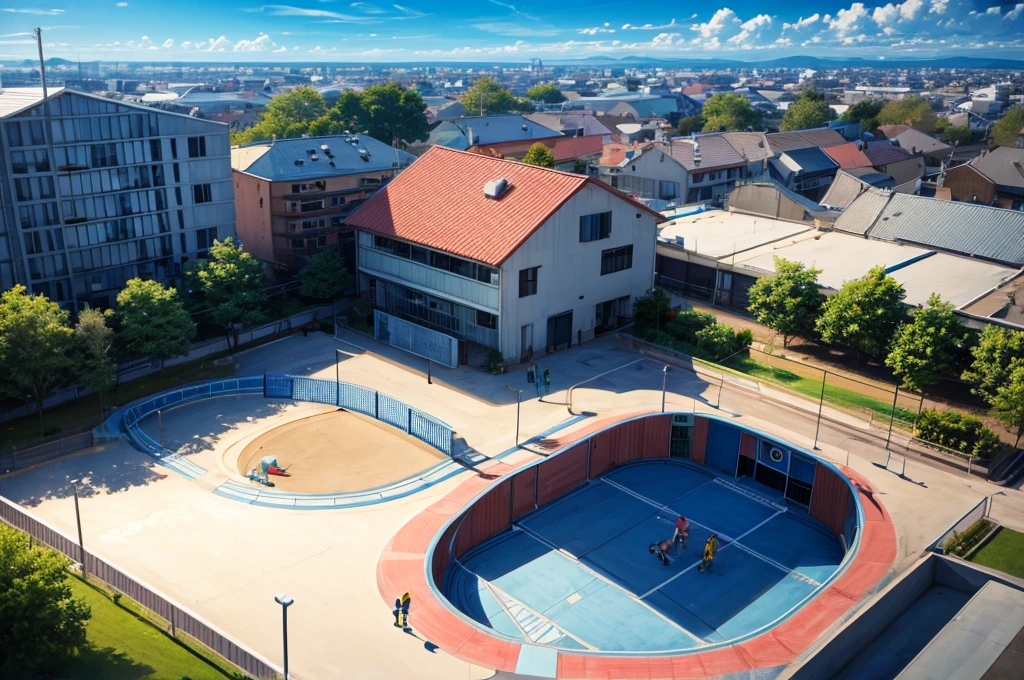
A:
[345,146,663,266]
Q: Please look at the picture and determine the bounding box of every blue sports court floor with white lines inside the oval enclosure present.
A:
[444,459,844,651]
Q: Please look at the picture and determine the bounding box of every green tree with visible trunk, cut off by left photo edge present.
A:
[0,285,74,436]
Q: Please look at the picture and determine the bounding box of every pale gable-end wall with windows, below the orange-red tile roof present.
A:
[499,185,656,357]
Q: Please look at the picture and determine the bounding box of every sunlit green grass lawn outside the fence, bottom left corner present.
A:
[56,578,238,680]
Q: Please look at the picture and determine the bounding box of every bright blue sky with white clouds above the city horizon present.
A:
[0,0,1024,62]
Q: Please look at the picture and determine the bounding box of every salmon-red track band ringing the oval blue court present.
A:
[377,414,896,679]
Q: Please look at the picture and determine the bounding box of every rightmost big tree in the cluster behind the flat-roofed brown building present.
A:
[356,83,428,144]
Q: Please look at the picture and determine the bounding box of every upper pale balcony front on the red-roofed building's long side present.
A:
[358,246,501,314]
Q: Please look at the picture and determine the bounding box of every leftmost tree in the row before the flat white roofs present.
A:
[748,257,824,347]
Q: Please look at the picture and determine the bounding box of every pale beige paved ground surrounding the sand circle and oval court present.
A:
[0,333,1024,680]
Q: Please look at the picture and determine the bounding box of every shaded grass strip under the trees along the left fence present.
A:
[0,352,234,451]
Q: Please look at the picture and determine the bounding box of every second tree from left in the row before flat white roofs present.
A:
[815,266,906,358]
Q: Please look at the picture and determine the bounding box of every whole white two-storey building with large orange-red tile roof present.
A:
[347,146,663,363]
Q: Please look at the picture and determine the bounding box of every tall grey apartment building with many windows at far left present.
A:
[0,88,234,308]
